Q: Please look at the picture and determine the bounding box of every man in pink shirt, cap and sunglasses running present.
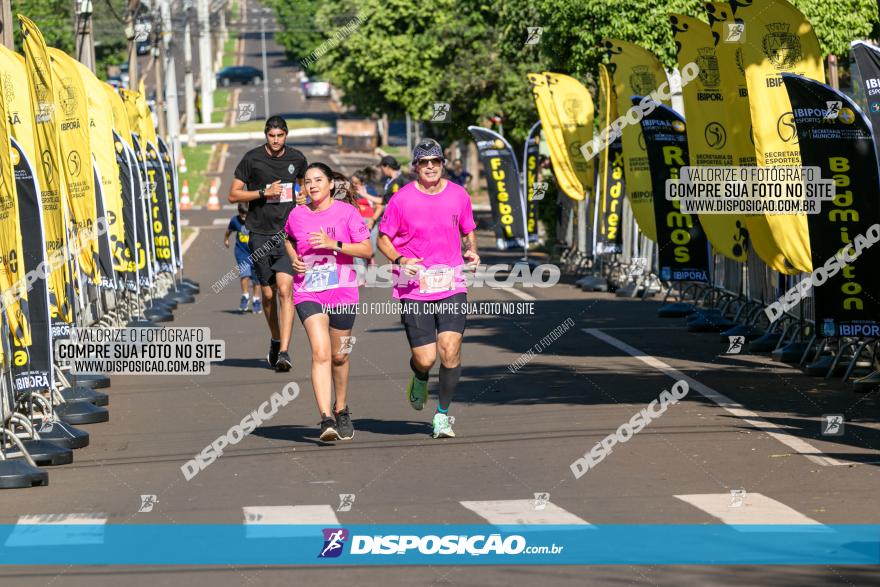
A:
[378,139,480,438]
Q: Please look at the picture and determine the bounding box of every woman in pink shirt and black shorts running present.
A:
[284,163,373,441]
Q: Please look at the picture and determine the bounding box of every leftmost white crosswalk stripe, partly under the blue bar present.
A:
[4,513,107,546]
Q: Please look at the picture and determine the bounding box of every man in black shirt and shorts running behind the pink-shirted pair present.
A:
[229,116,308,371]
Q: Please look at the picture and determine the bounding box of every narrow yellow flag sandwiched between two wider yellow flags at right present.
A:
[706,2,795,273]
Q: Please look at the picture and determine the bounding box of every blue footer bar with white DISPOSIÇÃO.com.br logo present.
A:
[0,524,880,566]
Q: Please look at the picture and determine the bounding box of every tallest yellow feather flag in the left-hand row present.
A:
[18,15,73,322]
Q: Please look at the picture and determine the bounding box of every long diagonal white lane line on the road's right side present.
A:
[581,328,849,467]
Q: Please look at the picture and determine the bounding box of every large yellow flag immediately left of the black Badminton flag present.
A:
[731,0,825,271]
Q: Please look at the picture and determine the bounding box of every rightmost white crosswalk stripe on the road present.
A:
[675,493,825,528]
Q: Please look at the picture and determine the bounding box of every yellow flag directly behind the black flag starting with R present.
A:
[605,39,669,241]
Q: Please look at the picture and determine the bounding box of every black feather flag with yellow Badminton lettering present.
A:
[782,73,880,336]
